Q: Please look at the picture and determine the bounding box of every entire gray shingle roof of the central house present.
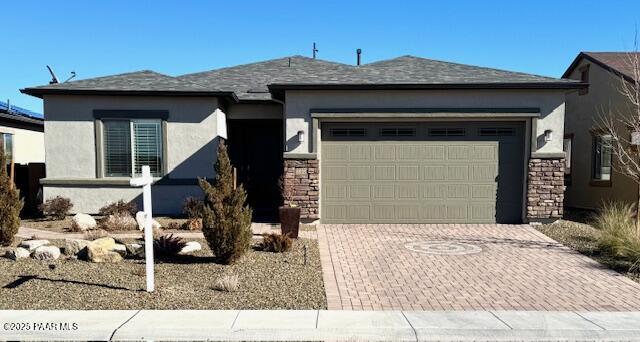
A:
[23,56,579,100]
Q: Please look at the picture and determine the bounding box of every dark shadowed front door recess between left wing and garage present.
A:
[227,119,283,221]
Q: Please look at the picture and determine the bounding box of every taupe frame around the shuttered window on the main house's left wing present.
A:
[95,115,168,179]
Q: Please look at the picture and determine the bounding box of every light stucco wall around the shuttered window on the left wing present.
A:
[44,95,219,213]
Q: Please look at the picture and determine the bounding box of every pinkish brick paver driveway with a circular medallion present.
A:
[318,224,640,310]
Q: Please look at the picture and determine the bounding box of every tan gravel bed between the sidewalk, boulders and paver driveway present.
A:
[0,239,326,310]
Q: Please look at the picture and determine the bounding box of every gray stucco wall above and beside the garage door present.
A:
[285,90,564,153]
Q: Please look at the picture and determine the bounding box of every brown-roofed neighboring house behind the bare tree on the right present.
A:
[562,52,638,209]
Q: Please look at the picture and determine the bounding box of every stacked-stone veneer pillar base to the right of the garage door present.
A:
[527,158,565,221]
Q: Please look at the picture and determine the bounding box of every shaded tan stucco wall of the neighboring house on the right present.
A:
[565,59,638,209]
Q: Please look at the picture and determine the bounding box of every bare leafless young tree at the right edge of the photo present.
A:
[598,45,640,234]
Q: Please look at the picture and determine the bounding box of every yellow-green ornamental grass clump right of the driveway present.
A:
[593,202,640,264]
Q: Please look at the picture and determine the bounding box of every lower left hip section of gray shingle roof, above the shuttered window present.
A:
[23,70,239,99]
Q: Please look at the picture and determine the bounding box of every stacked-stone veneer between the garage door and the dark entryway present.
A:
[284,159,320,220]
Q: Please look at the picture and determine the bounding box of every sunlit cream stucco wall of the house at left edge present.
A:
[0,126,45,164]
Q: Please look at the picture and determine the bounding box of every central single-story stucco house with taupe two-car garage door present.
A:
[22,56,584,223]
